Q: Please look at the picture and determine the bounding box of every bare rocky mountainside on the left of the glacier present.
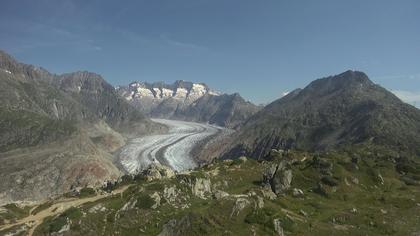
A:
[0,51,165,203]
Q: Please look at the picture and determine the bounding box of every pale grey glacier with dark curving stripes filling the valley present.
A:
[119,119,222,173]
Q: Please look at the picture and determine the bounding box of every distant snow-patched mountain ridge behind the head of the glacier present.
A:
[117,80,260,128]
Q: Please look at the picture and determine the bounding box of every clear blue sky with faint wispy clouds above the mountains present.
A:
[0,0,420,106]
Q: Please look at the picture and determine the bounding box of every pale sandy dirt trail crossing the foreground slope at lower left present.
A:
[0,185,130,236]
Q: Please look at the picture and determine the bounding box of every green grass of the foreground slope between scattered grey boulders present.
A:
[0,147,414,235]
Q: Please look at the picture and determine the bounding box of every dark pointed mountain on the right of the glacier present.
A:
[220,71,420,158]
